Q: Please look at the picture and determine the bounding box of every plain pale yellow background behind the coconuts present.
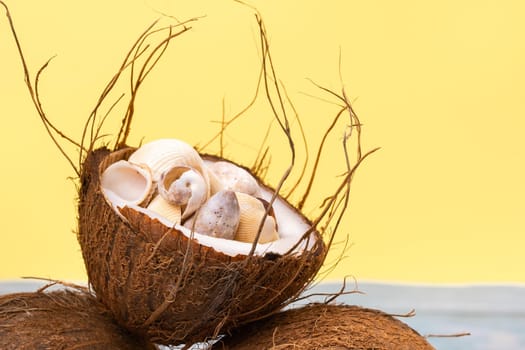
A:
[0,0,525,283]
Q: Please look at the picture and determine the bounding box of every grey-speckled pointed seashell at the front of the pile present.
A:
[184,190,240,239]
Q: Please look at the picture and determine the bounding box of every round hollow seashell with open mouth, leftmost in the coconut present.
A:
[101,160,154,206]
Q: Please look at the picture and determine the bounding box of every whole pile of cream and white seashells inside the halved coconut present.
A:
[101,139,279,243]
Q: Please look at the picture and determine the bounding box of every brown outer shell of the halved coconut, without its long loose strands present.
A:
[79,148,326,345]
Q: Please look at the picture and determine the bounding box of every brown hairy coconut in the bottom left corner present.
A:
[0,290,156,350]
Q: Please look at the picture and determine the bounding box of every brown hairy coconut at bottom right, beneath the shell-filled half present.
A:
[213,304,434,350]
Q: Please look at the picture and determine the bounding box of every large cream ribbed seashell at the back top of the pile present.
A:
[128,139,208,182]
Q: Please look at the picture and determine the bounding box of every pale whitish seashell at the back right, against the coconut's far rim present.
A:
[208,161,261,197]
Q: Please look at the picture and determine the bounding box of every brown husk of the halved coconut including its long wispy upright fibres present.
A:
[0,1,375,345]
